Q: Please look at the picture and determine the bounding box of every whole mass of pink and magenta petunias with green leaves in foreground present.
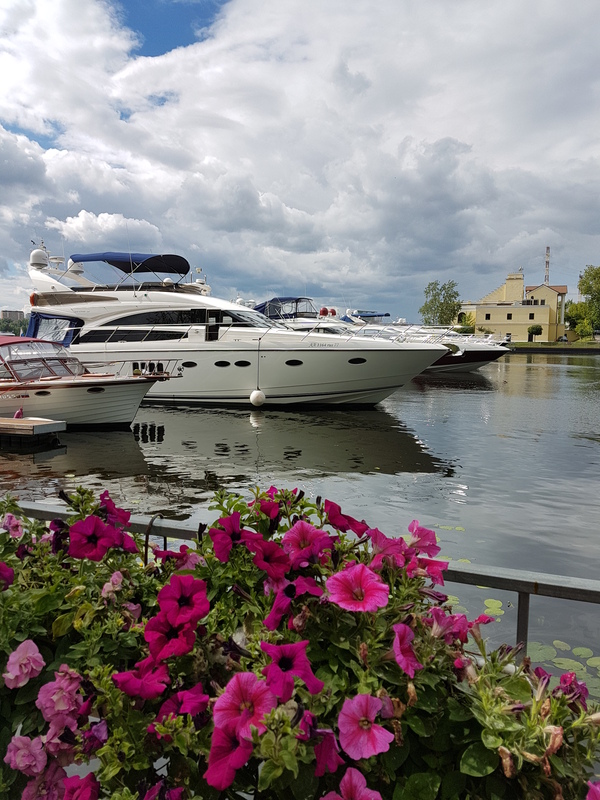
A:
[0,487,600,800]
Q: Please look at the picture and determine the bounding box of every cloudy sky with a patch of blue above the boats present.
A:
[0,0,600,321]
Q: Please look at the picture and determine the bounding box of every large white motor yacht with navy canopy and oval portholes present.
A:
[27,248,446,406]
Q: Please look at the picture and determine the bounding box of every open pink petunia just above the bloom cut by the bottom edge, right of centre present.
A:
[338,694,394,761]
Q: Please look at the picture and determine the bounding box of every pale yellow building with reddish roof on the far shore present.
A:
[458,271,567,342]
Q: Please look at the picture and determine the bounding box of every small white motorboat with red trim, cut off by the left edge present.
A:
[0,335,168,427]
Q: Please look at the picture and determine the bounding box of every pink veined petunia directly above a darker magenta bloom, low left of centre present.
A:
[213,672,277,737]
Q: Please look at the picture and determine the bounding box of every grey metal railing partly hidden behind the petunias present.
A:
[19,500,600,655]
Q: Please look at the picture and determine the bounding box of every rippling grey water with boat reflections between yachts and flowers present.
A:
[0,354,600,676]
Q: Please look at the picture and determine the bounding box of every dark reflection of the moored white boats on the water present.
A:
[0,406,452,518]
